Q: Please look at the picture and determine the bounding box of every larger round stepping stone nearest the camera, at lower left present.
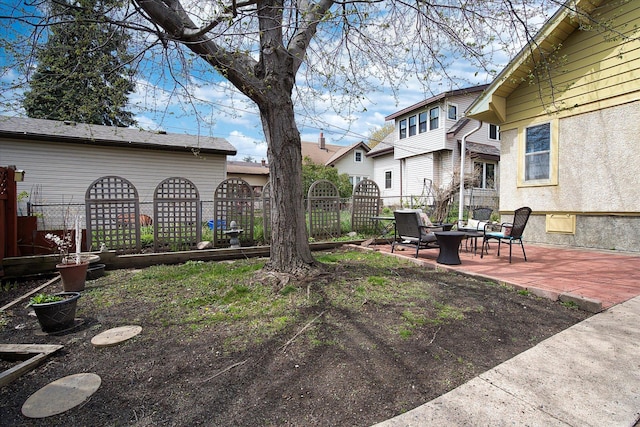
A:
[22,373,102,418]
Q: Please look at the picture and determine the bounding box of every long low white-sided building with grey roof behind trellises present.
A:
[0,116,236,227]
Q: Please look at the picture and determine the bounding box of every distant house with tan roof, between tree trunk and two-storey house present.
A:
[302,133,373,186]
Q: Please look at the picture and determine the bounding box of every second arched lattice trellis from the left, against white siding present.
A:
[153,177,202,252]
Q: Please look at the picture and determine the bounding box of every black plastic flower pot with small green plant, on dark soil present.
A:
[29,292,80,333]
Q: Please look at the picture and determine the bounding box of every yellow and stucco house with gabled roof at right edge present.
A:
[468,0,640,252]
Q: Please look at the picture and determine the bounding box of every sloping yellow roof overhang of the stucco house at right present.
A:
[467,0,603,124]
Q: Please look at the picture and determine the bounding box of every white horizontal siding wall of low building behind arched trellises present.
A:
[0,140,226,227]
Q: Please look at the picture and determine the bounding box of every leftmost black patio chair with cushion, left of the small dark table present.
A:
[391,211,442,258]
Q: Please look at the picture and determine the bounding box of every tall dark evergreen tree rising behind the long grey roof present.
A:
[22,0,136,126]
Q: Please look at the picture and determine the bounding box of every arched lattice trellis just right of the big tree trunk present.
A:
[307,179,340,238]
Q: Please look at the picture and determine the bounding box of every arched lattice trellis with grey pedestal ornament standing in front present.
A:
[213,178,255,247]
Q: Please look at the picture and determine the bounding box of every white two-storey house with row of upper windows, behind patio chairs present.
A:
[378,85,500,209]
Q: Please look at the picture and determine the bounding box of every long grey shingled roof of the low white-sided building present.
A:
[0,116,237,156]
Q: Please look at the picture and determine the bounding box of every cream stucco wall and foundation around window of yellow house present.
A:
[500,101,640,252]
